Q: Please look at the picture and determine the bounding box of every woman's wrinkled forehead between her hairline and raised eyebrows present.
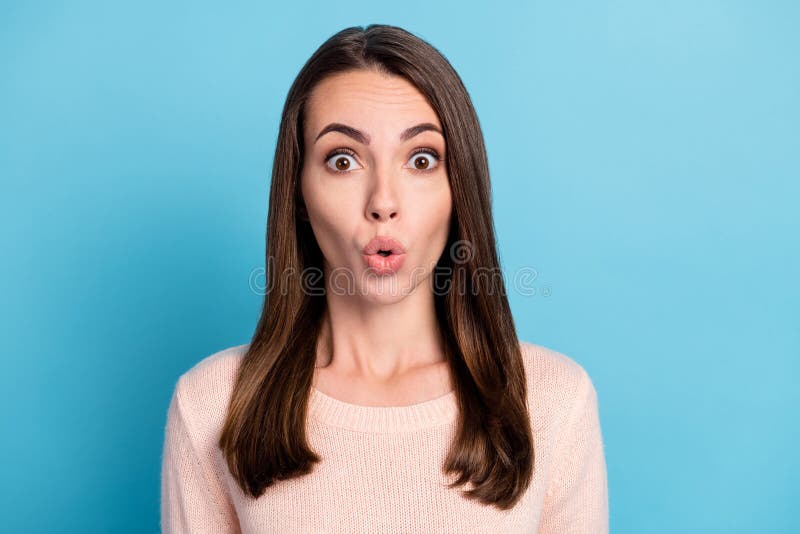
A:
[306,70,441,136]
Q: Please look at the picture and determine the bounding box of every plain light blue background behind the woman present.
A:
[0,0,800,534]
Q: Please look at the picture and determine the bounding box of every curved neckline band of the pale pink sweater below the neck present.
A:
[309,385,458,433]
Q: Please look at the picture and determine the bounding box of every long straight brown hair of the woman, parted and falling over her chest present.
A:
[219,24,534,510]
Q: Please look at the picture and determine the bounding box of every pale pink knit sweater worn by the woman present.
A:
[161,341,608,534]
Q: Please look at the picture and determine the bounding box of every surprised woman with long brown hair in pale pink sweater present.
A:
[162,25,608,533]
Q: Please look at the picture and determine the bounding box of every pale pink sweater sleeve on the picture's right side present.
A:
[539,368,609,534]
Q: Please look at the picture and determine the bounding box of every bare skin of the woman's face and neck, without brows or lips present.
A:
[301,70,453,406]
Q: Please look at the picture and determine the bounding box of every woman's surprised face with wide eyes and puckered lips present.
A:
[301,70,452,301]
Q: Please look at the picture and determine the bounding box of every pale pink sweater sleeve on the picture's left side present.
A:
[161,381,241,534]
